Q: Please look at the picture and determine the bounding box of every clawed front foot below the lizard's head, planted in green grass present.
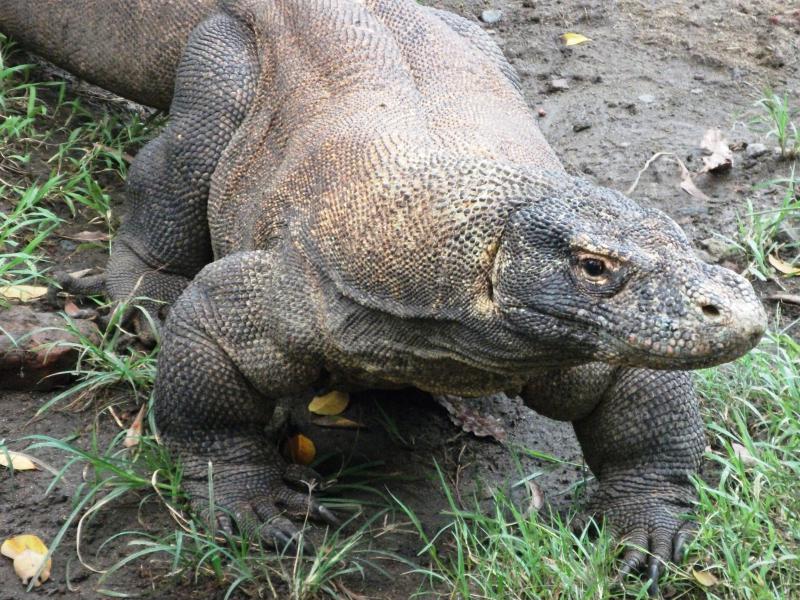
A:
[573,486,697,596]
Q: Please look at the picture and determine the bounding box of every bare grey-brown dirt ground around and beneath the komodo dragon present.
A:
[0,0,800,600]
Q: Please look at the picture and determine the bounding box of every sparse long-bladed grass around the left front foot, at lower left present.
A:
[19,409,389,600]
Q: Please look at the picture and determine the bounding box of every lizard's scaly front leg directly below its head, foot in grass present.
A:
[524,363,705,592]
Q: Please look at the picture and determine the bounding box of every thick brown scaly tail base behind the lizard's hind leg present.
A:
[0,0,217,109]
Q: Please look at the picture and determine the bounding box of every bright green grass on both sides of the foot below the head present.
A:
[397,334,800,600]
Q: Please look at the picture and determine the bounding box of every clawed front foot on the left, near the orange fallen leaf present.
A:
[184,455,340,554]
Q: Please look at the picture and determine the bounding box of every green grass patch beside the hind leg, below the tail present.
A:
[0,34,161,287]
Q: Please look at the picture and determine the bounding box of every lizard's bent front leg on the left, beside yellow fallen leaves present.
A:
[155,252,336,550]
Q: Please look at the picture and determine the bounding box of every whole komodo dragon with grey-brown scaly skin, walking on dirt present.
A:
[0,0,765,592]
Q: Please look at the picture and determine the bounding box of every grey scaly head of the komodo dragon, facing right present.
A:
[491,179,766,369]
